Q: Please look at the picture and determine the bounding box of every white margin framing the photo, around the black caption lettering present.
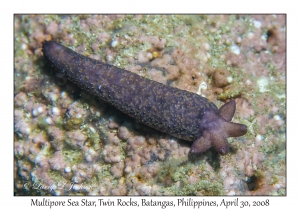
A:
[0,0,300,209]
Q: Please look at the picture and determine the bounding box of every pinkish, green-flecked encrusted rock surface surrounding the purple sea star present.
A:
[14,15,286,195]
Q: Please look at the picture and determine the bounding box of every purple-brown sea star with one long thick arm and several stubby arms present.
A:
[43,41,247,155]
